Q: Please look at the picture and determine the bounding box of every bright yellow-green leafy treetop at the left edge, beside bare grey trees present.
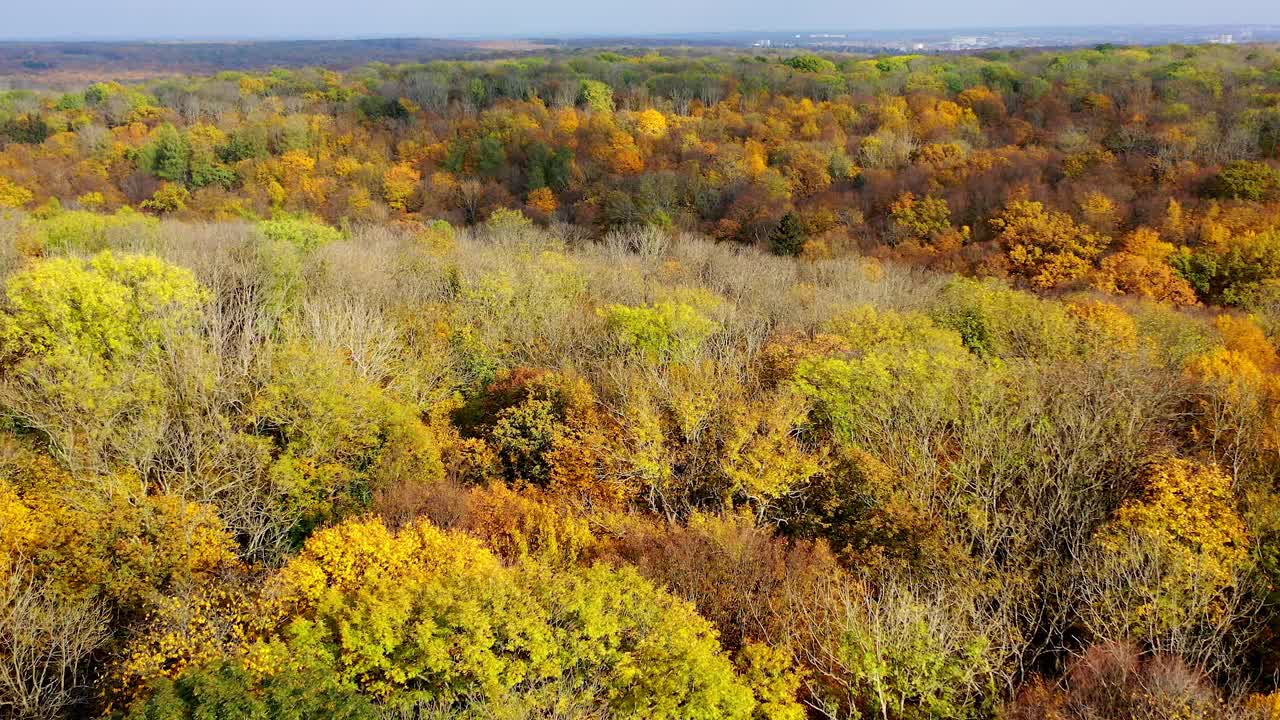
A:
[0,252,209,469]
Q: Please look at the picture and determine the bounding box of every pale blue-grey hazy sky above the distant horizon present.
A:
[0,0,1280,40]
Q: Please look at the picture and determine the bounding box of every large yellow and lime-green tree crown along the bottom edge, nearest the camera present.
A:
[213,523,755,720]
